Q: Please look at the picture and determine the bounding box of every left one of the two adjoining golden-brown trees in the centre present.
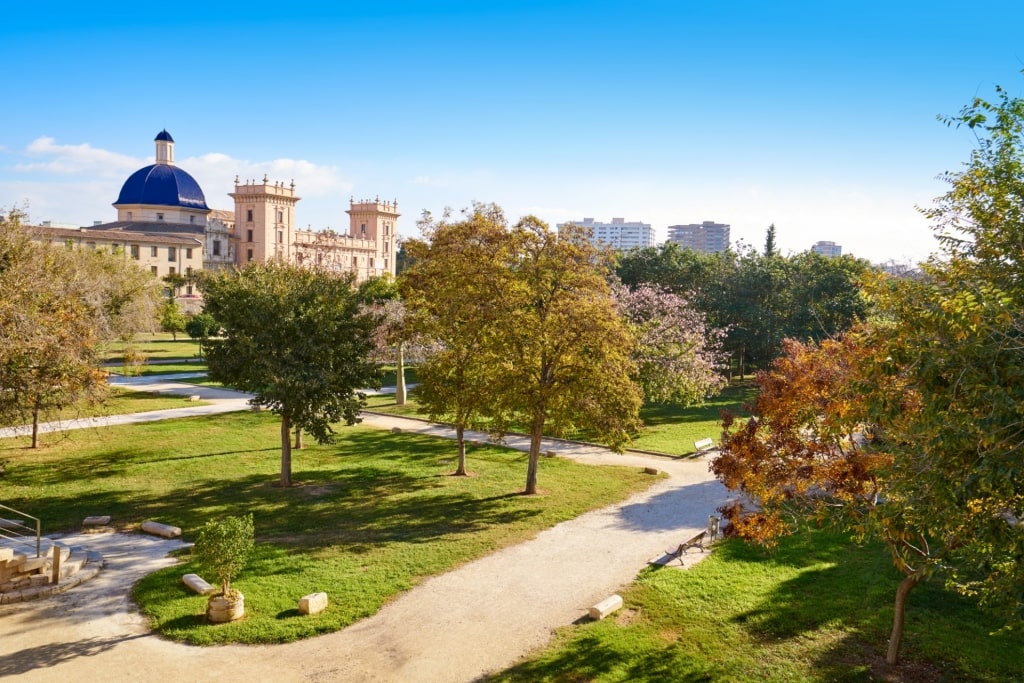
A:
[400,204,511,475]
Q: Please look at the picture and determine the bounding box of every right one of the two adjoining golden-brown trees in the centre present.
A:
[487,216,640,494]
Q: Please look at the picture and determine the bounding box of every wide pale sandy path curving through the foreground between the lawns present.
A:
[0,403,727,683]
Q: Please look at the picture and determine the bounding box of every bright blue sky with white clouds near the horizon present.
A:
[0,0,1024,261]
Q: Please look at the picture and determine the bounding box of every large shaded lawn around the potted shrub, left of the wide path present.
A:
[0,413,651,643]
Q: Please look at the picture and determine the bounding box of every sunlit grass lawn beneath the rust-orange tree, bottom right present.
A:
[487,531,1024,683]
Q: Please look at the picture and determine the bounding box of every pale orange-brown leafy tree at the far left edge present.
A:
[0,209,156,447]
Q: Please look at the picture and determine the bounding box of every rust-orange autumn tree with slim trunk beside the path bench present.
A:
[712,326,937,664]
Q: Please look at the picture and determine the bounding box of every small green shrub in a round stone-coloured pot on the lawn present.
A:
[193,514,255,623]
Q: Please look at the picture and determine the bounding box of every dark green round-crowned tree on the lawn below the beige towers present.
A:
[202,263,379,486]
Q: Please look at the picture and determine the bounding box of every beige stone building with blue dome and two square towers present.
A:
[28,130,399,288]
